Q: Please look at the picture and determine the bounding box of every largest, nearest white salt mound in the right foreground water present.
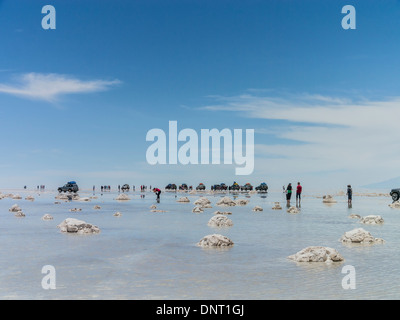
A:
[288,246,344,263]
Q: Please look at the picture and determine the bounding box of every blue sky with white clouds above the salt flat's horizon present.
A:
[0,0,400,188]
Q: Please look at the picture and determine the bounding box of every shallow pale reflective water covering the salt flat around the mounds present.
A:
[0,191,400,300]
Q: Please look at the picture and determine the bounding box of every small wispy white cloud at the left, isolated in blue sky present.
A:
[0,73,120,102]
